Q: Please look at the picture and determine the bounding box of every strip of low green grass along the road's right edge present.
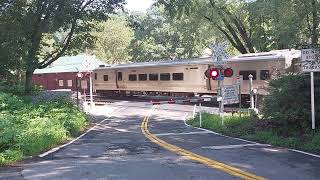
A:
[187,113,320,153]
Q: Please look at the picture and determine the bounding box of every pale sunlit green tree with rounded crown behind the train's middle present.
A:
[129,6,214,61]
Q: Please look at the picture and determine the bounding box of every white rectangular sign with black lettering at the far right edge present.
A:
[301,48,320,72]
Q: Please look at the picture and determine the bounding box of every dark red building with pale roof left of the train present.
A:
[32,55,106,91]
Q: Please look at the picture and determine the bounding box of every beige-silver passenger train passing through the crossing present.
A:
[93,50,300,96]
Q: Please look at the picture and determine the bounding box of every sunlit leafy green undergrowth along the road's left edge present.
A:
[0,93,88,165]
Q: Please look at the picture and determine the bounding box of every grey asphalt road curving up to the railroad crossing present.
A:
[0,101,320,180]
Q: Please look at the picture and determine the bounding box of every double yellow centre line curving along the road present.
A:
[141,106,265,180]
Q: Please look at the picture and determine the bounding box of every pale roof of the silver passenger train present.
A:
[96,50,301,70]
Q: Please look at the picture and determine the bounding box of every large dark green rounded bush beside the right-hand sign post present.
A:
[262,74,320,135]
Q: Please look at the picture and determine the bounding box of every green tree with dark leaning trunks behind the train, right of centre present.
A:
[158,0,255,54]
